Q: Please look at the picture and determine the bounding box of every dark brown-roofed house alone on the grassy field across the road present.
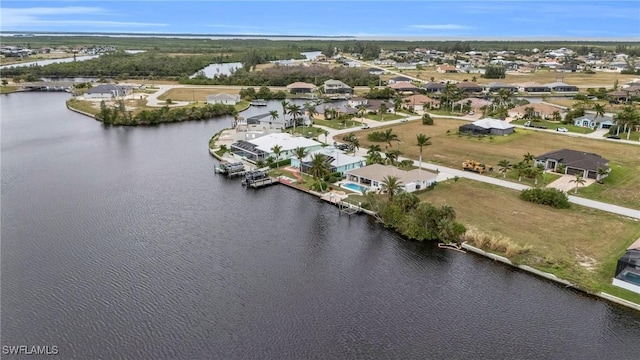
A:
[536,149,609,181]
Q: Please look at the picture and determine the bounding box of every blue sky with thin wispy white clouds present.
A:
[0,0,640,41]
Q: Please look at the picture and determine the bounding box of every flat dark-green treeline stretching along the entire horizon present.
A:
[2,35,640,59]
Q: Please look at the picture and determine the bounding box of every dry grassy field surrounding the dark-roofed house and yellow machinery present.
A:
[356,118,640,209]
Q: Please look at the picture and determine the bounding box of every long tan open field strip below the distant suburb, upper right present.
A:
[392,67,638,88]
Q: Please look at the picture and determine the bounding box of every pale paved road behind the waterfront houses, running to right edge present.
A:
[314,116,640,220]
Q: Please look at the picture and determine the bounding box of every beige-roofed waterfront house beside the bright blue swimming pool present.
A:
[345,164,437,192]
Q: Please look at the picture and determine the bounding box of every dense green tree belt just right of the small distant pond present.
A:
[180,66,379,86]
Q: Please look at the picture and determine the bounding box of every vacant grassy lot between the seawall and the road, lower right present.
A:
[420,179,640,303]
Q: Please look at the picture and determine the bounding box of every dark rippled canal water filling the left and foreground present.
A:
[0,93,640,359]
